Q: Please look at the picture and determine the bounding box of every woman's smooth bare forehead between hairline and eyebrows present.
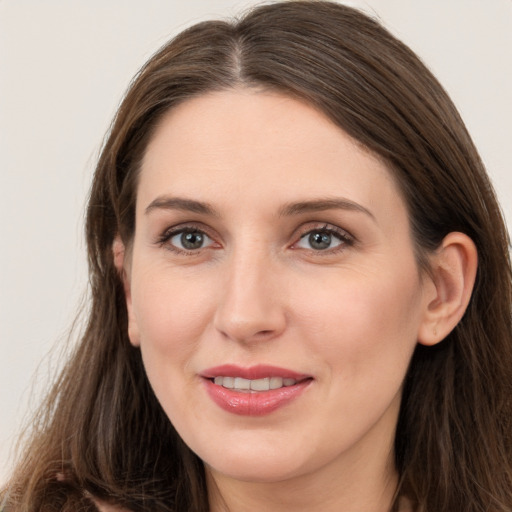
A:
[138,89,403,222]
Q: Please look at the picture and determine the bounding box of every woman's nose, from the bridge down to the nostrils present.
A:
[214,251,287,343]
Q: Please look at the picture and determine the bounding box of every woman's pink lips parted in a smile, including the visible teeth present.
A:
[201,365,313,416]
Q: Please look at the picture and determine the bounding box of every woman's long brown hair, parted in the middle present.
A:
[4,1,512,512]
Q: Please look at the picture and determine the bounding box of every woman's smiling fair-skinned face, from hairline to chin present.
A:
[125,89,434,482]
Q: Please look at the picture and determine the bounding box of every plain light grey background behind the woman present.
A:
[0,0,512,481]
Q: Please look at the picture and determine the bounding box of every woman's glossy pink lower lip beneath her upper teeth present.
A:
[204,379,312,416]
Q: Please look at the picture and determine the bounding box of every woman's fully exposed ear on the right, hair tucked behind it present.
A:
[418,232,478,345]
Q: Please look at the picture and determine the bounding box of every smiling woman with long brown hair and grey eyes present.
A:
[5,1,512,512]
